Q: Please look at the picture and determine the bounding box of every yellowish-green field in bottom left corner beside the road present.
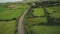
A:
[0,20,16,34]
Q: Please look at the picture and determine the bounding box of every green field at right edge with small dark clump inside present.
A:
[46,6,60,18]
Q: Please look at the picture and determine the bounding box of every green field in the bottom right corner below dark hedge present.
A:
[32,26,60,34]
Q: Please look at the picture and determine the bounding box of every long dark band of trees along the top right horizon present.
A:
[27,1,60,8]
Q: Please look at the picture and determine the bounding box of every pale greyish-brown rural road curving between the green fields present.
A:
[18,8,30,34]
